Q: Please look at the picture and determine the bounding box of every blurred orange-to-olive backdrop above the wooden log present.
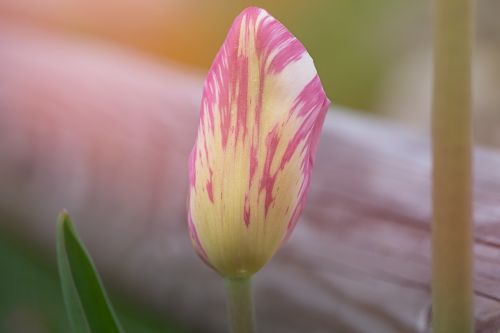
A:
[0,0,500,144]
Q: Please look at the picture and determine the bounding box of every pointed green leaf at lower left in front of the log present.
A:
[57,211,122,333]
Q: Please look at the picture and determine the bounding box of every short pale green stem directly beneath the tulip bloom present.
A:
[225,278,255,333]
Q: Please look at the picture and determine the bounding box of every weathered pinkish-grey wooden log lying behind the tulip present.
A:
[0,22,500,333]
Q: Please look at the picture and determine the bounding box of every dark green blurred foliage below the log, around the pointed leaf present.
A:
[0,230,186,333]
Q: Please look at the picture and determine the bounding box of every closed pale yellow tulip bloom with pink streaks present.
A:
[188,8,330,278]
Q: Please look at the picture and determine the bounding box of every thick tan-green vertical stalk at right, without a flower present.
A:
[432,0,474,333]
